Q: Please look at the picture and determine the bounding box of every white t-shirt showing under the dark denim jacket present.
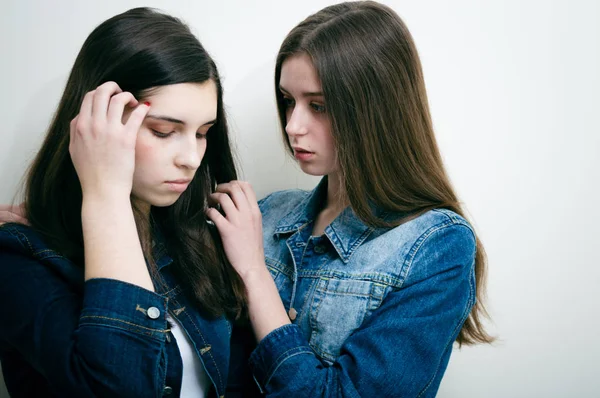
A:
[167,315,210,397]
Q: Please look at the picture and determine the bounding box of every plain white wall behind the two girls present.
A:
[0,0,600,398]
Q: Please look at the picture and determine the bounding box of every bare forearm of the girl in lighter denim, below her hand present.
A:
[243,264,290,341]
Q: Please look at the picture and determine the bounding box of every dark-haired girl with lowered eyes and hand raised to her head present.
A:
[0,8,251,398]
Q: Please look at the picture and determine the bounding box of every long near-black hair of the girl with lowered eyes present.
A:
[24,8,246,317]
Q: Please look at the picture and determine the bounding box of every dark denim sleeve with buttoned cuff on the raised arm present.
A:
[0,251,167,397]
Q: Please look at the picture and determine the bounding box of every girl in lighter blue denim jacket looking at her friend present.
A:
[208,2,492,397]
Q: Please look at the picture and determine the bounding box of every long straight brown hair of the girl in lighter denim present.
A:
[275,1,493,344]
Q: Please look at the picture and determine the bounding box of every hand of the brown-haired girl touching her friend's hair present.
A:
[206,181,265,279]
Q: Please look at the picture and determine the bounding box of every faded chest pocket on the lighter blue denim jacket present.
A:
[309,277,389,363]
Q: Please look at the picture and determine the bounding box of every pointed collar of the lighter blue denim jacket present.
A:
[275,177,382,263]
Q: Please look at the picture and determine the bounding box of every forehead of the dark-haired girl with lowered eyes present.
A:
[144,80,217,126]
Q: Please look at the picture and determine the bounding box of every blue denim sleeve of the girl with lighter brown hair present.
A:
[250,224,475,397]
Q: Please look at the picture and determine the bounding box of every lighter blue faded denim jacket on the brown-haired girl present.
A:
[250,178,475,397]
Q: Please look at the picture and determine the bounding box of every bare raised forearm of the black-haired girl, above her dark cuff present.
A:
[81,197,154,291]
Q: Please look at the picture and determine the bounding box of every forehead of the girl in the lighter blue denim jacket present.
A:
[279,53,321,92]
